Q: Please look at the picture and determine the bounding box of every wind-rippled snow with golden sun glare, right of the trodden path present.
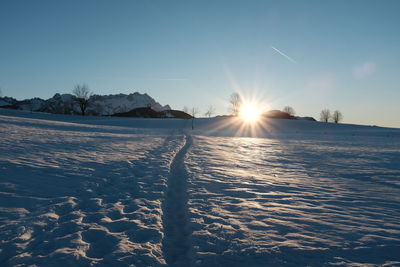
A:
[187,136,400,266]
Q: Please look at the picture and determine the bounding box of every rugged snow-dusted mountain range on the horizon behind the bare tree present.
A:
[0,92,171,115]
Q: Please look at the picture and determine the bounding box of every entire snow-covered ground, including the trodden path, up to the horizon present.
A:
[0,109,400,266]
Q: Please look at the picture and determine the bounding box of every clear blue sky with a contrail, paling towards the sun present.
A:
[0,0,400,127]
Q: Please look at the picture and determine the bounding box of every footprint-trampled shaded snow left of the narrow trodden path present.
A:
[0,114,182,266]
